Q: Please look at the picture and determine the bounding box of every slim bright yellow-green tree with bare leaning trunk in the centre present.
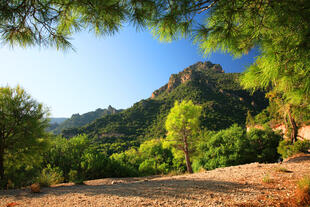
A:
[166,101,202,173]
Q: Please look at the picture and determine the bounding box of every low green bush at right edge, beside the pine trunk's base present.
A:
[278,140,310,158]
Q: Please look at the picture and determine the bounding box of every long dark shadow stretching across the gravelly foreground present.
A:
[0,178,274,199]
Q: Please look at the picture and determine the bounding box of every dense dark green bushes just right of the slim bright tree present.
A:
[195,125,281,170]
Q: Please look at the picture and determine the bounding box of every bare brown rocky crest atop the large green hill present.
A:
[151,61,224,98]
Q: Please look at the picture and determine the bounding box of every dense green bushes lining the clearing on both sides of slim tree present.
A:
[41,125,281,183]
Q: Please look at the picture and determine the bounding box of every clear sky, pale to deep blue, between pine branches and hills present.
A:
[0,27,257,117]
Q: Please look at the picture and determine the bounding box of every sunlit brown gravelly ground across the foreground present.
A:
[0,154,310,207]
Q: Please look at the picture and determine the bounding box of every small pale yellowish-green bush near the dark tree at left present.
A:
[38,165,64,187]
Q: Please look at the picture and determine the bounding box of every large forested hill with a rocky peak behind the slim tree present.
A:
[63,62,268,146]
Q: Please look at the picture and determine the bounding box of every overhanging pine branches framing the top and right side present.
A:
[0,0,310,106]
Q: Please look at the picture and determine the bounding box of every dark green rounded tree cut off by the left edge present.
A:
[0,86,48,184]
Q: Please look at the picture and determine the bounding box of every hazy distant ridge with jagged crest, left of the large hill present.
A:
[49,106,121,134]
